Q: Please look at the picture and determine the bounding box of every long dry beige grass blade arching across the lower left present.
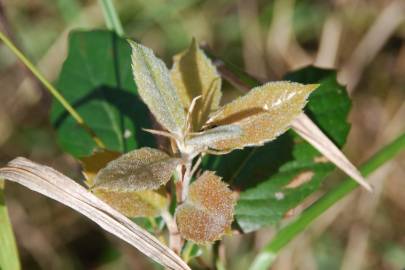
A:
[0,158,190,270]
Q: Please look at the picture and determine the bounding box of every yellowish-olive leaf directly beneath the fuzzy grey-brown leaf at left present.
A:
[94,189,169,218]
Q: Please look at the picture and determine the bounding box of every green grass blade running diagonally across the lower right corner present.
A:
[246,134,405,270]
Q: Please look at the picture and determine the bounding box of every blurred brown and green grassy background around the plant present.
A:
[0,0,405,270]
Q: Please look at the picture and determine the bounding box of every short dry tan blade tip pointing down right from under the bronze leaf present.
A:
[292,113,372,191]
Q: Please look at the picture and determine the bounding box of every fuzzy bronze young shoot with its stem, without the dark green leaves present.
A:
[83,40,318,244]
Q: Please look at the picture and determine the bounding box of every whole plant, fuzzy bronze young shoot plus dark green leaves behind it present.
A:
[52,31,350,243]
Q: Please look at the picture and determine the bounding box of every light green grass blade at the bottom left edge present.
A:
[0,180,21,270]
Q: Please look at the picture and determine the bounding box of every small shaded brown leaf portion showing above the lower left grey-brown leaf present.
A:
[80,149,122,187]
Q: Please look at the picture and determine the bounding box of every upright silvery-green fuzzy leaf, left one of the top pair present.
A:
[128,40,186,136]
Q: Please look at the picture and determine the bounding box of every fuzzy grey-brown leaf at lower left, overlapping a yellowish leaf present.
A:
[93,147,180,191]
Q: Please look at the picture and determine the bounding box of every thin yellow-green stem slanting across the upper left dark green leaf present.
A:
[0,31,105,148]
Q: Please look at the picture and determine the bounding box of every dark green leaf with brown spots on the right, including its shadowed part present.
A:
[204,67,350,232]
